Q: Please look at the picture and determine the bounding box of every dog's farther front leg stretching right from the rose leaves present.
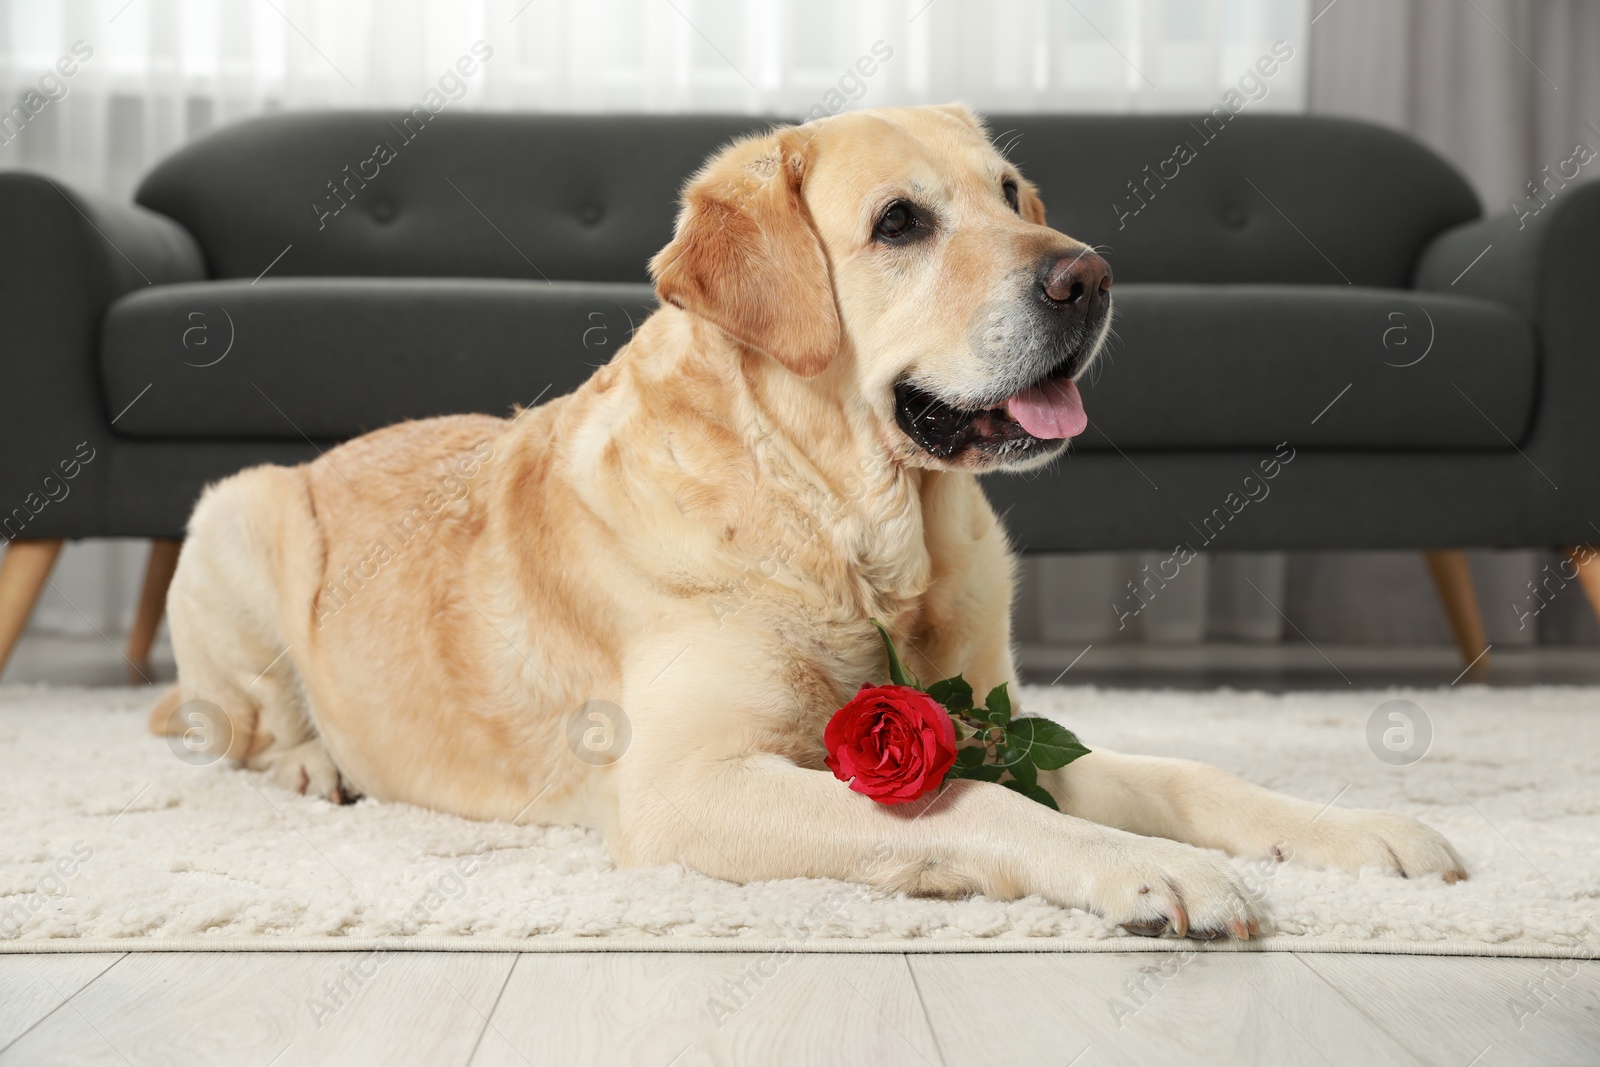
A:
[1040,750,1467,881]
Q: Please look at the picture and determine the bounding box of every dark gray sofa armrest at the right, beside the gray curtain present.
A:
[1413,182,1600,544]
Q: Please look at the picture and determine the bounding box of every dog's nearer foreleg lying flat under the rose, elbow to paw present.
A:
[613,755,1256,937]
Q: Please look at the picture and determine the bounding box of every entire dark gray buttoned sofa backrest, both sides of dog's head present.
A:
[138,107,1478,286]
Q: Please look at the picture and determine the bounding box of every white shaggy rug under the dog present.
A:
[0,686,1600,955]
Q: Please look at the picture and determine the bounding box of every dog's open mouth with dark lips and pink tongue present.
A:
[894,360,1088,459]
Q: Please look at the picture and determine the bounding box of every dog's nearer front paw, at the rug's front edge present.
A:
[1078,829,1261,941]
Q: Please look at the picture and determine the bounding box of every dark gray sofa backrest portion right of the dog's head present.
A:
[989,107,1478,288]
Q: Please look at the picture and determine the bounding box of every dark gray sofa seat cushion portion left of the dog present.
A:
[101,278,656,442]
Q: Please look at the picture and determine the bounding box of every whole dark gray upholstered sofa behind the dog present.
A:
[0,112,1600,675]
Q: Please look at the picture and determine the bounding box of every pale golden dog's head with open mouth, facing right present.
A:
[651,106,1112,470]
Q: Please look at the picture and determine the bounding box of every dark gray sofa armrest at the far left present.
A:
[0,173,206,541]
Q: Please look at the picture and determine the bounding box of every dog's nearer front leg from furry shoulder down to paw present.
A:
[608,646,1256,937]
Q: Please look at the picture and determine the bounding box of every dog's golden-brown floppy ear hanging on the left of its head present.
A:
[650,128,840,378]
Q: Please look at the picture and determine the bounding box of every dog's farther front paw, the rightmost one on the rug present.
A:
[1282,808,1467,883]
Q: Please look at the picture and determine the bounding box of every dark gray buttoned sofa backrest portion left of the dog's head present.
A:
[136,109,773,282]
